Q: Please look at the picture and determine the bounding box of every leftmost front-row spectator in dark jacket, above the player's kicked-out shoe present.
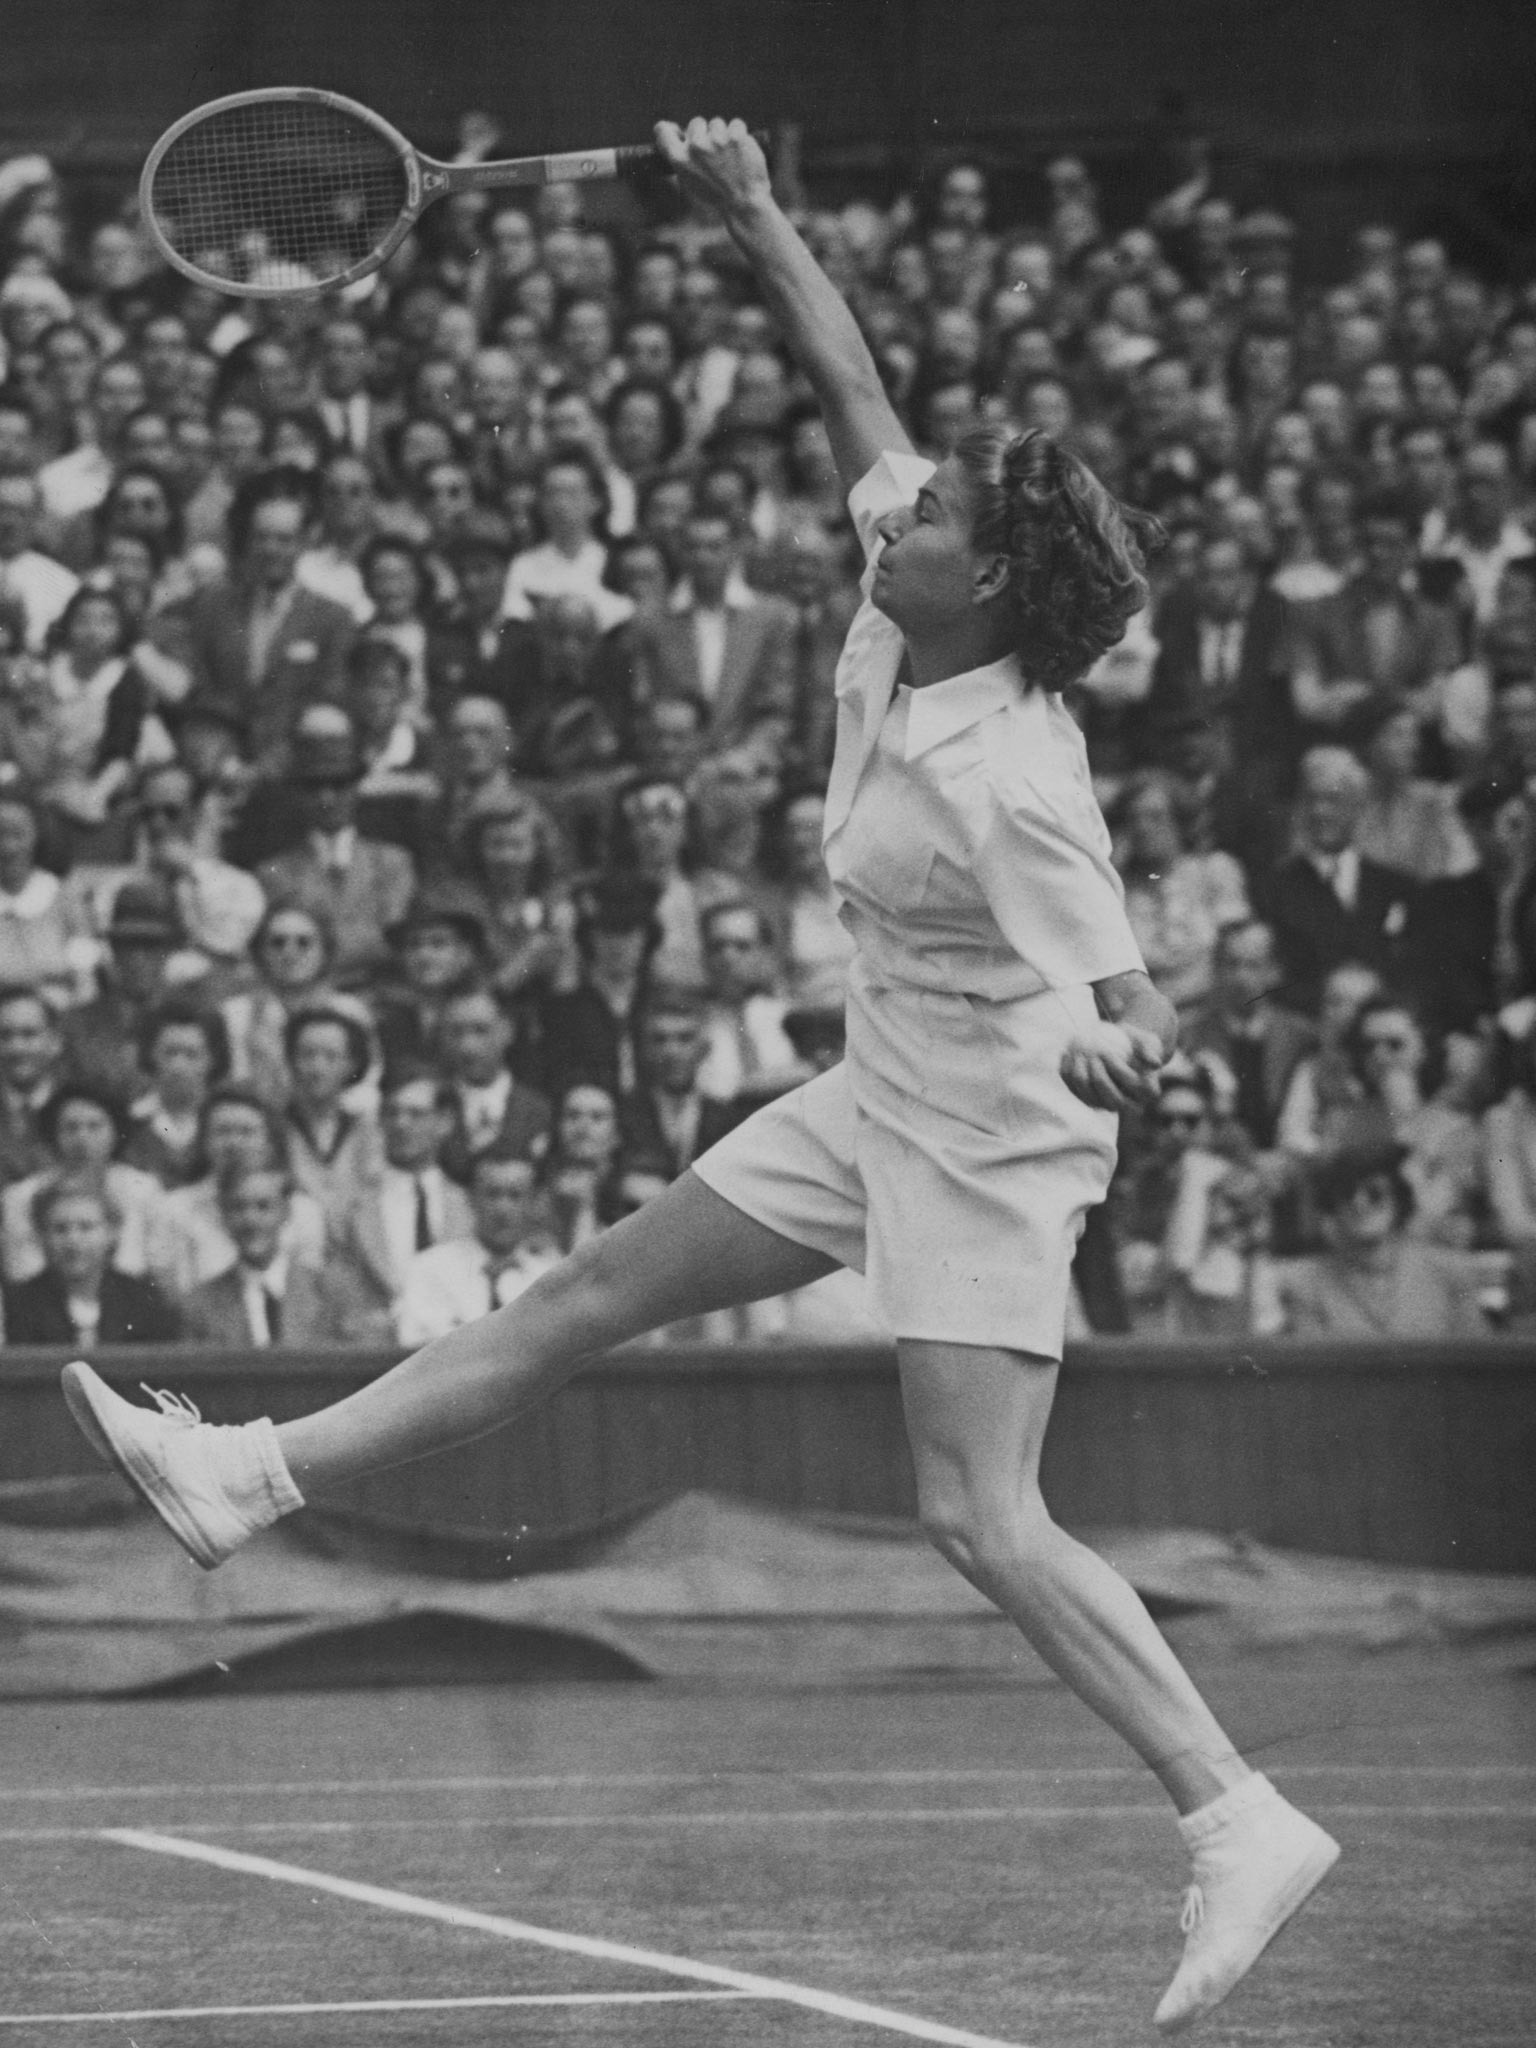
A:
[0,1174,180,1352]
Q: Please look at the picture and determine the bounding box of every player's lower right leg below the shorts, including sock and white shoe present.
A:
[899,1341,1339,2032]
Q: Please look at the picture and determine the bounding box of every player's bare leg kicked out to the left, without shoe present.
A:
[276,1174,836,1487]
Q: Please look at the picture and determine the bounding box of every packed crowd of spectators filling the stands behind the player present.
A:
[0,119,1536,1348]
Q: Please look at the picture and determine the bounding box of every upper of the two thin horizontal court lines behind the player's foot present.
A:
[0,1763,1536,1802]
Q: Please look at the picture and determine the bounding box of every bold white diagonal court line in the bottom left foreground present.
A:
[111,1827,1024,2048]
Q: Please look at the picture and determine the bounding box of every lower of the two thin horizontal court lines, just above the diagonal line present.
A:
[0,1800,1536,1841]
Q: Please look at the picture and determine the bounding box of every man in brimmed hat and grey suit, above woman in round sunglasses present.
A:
[256,705,416,987]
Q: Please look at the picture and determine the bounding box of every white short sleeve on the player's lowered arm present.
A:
[975,772,1145,989]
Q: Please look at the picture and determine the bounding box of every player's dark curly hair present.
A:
[954,426,1163,692]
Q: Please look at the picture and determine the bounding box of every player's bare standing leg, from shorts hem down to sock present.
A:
[899,1341,1249,1812]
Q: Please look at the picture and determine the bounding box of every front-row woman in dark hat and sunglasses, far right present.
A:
[1278,1145,1489,1341]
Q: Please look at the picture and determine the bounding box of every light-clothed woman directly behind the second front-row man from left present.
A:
[145,1081,326,1300]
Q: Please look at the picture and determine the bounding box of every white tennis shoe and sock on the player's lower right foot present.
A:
[1153,1772,1339,2034]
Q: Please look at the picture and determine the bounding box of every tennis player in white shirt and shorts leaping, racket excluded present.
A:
[63,121,1337,2030]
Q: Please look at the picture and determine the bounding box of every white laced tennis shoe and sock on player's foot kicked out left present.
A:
[61,1360,303,1571]
